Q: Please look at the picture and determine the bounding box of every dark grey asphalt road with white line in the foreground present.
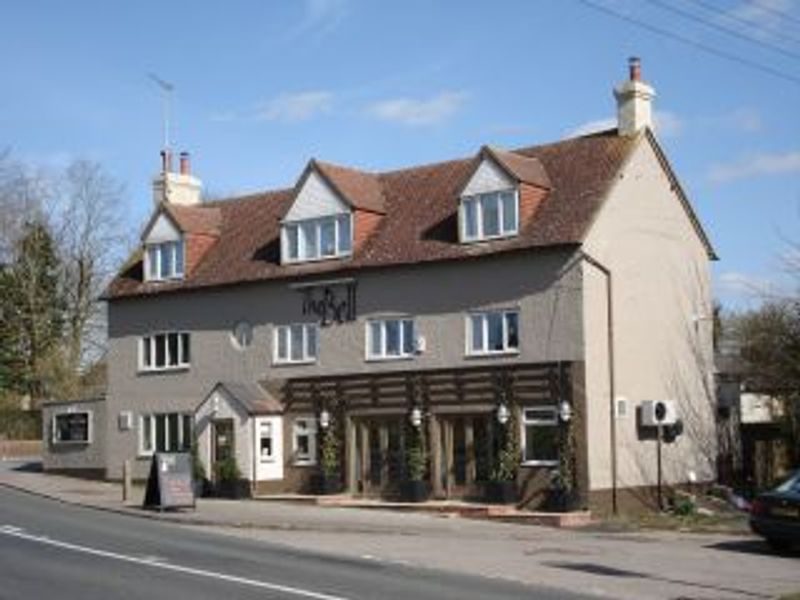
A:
[0,487,587,600]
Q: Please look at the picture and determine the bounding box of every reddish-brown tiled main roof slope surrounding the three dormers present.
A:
[107,130,639,298]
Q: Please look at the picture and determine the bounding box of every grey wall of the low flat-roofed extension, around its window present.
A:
[42,399,107,471]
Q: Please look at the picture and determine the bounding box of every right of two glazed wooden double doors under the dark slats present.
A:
[439,415,493,498]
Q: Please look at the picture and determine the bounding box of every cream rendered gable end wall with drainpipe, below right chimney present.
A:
[583,136,716,490]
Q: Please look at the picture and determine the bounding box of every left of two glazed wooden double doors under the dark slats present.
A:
[354,417,405,497]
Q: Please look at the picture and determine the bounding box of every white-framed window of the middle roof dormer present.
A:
[281,213,353,263]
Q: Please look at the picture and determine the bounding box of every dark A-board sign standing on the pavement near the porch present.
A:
[144,452,195,509]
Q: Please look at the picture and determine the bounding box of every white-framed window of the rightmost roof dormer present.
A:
[461,190,519,242]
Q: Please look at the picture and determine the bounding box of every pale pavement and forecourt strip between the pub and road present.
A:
[0,463,800,600]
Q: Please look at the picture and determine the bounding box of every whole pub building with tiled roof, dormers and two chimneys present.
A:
[97,60,715,511]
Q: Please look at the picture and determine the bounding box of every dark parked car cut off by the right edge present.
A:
[750,469,800,550]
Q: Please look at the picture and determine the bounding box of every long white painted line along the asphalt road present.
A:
[0,525,348,600]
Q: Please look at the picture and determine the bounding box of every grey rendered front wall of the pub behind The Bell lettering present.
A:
[107,250,583,478]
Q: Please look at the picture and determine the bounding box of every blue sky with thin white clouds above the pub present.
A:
[0,0,800,307]
